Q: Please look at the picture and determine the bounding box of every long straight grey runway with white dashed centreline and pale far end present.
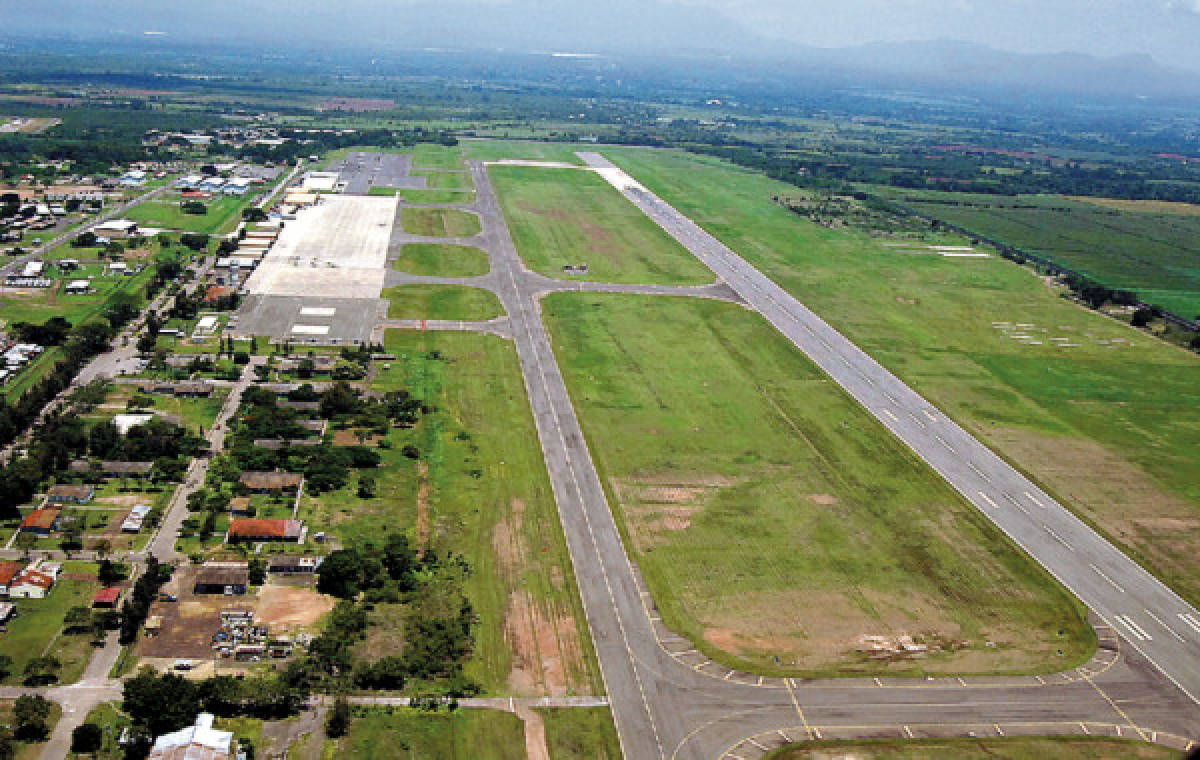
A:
[580,154,1200,701]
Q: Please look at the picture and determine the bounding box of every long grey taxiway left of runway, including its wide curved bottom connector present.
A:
[470,162,1200,760]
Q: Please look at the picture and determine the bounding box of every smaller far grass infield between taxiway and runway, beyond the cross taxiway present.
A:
[488,166,713,285]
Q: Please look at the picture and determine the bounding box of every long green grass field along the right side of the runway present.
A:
[605,150,1200,603]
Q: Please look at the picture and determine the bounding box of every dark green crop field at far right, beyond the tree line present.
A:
[887,190,1200,318]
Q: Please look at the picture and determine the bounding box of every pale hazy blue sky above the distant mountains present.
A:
[7,0,1200,71]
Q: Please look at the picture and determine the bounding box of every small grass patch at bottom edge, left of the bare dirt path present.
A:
[324,707,526,760]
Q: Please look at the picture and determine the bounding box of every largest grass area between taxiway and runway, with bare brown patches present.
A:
[544,293,1094,675]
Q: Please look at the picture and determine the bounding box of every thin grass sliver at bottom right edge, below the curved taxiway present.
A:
[763,737,1182,760]
